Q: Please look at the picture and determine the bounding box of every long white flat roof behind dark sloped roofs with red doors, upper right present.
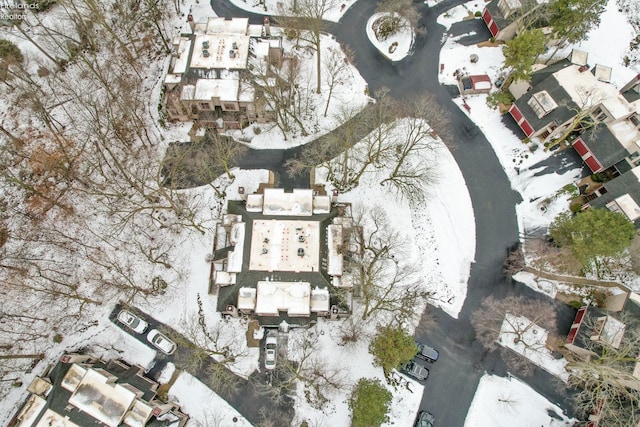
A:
[554,65,634,119]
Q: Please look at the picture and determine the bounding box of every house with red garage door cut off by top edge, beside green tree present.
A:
[482,0,550,41]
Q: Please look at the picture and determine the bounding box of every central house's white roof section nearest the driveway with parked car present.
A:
[256,282,311,316]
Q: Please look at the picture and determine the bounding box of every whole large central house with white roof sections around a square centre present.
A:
[210,188,356,326]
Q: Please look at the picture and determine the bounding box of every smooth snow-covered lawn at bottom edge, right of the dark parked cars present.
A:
[464,374,575,427]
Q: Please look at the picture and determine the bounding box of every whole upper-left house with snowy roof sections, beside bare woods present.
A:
[163,15,283,130]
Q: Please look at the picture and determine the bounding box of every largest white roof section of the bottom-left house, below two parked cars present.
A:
[69,369,136,427]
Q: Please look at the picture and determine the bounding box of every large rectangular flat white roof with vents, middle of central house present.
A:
[249,220,320,272]
